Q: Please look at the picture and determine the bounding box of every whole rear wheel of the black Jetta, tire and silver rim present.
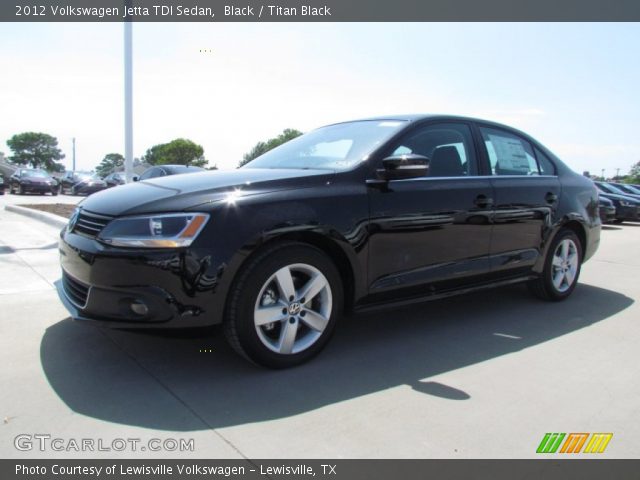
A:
[528,228,582,302]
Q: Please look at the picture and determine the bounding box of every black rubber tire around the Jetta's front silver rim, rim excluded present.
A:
[228,244,343,368]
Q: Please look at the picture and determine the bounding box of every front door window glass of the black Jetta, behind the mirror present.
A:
[389,123,477,177]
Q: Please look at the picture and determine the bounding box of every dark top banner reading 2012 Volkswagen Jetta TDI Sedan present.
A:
[0,0,640,22]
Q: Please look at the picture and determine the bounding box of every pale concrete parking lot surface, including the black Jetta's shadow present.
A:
[0,195,640,458]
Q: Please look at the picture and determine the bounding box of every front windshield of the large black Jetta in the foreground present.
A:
[243,120,406,170]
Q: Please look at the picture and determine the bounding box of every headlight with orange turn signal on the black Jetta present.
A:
[98,213,209,248]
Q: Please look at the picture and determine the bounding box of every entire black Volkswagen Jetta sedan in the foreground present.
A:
[60,116,601,367]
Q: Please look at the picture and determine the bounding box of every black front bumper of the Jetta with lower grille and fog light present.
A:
[57,230,224,328]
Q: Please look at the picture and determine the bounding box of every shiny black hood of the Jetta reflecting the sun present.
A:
[80,168,335,216]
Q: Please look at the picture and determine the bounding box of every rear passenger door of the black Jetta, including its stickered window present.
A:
[479,125,561,274]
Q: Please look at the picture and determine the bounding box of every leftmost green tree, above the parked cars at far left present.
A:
[7,132,64,171]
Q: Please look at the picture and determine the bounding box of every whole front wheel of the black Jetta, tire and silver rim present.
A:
[223,242,344,368]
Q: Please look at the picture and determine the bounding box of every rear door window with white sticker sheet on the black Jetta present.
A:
[480,127,540,175]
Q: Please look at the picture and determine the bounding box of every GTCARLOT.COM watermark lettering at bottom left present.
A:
[13,433,195,452]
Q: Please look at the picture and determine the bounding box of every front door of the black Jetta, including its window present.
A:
[369,122,493,294]
